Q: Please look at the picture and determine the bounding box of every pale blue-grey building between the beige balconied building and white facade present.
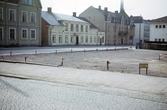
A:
[133,16,150,46]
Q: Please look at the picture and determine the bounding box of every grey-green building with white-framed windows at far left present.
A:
[0,0,42,46]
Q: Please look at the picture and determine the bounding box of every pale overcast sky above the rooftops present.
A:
[41,0,167,20]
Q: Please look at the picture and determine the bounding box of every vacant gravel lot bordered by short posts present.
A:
[0,50,167,77]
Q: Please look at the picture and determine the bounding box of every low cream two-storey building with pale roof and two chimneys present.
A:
[42,8,105,46]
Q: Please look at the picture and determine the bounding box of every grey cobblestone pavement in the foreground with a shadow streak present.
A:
[0,77,167,110]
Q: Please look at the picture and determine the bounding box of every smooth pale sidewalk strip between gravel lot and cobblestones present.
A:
[0,62,167,99]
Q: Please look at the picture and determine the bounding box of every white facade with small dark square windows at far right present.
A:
[149,16,167,42]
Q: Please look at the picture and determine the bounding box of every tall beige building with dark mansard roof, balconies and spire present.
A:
[79,1,135,45]
